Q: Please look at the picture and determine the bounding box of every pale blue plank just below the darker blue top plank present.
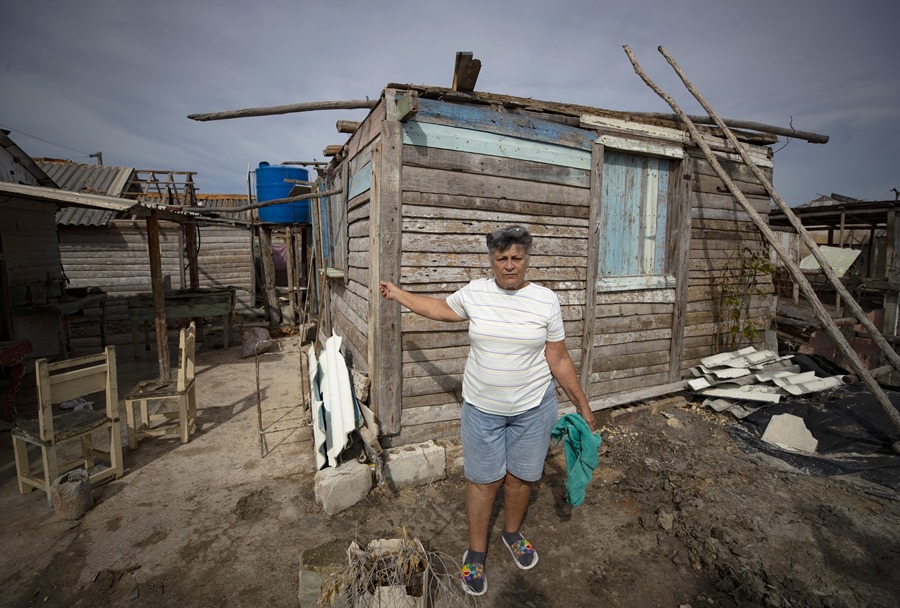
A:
[403,121,591,171]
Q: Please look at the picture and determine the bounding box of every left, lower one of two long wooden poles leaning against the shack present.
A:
[624,45,900,436]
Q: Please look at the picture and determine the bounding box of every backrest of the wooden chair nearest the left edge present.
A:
[35,346,119,442]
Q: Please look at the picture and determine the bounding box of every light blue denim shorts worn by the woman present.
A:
[460,380,559,484]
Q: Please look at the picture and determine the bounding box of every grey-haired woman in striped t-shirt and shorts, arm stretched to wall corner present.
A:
[380,226,597,595]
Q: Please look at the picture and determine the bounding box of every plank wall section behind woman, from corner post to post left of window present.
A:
[387,100,591,445]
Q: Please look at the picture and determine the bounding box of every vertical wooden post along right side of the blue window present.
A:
[666,155,696,382]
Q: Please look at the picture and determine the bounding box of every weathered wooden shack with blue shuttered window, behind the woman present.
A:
[313,85,777,445]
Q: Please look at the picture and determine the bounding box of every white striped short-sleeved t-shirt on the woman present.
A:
[447,279,566,416]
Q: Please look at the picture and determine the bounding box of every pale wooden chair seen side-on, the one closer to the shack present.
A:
[125,322,197,450]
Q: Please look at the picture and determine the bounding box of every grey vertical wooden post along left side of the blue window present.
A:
[579,143,606,401]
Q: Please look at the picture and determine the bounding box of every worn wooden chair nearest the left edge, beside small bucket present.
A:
[12,346,123,503]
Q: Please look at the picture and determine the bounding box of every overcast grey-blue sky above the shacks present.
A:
[0,0,900,205]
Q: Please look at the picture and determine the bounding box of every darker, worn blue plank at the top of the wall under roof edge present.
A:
[416,98,597,152]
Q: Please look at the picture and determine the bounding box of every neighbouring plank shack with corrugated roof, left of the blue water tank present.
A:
[36,159,255,340]
